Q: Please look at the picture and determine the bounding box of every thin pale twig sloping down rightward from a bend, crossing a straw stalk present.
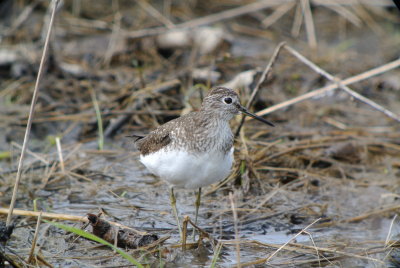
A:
[285,45,400,122]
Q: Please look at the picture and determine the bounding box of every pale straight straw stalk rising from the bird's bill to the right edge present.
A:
[252,56,400,120]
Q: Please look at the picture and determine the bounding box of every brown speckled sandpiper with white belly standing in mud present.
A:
[133,87,273,238]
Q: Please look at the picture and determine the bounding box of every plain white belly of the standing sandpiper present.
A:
[140,147,233,189]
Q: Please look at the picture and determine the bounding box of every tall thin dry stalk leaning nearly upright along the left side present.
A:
[6,0,60,225]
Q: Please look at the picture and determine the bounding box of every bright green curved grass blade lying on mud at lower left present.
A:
[43,220,144,268]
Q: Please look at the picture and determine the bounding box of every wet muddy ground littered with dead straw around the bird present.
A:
[0,0,400,267]
